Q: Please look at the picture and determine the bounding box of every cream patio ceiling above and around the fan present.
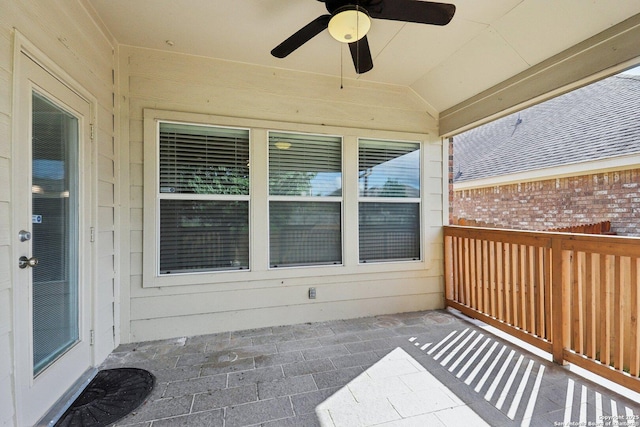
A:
[87,0,640,111]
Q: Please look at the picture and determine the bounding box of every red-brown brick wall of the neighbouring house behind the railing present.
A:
[453,169,640,236]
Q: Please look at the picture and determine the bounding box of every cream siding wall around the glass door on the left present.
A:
[0,0,117,426]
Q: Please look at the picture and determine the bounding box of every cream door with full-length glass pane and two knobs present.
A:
[12,54,92,425]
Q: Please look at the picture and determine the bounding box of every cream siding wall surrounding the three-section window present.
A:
[119,47,443,342]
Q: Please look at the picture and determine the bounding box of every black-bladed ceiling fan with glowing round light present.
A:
[271,0,456,74]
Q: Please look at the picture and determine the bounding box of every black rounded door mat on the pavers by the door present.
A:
[56,368,155,427]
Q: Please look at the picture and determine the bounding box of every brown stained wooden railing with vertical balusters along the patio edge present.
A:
[444,226,640,392]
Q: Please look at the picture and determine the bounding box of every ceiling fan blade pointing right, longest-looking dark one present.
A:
[369,0,456,25]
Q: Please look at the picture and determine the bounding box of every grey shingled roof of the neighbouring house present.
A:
[453,74,640,182]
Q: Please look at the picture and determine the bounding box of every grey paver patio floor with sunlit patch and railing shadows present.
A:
[101,311,640,427]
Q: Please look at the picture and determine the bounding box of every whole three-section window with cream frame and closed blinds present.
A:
[143,109,428,287]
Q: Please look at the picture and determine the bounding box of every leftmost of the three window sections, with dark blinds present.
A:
[158,122,249,274]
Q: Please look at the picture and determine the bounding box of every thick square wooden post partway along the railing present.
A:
[551,237,569,365]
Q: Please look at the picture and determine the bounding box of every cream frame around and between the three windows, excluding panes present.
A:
[144,108,436,291]
